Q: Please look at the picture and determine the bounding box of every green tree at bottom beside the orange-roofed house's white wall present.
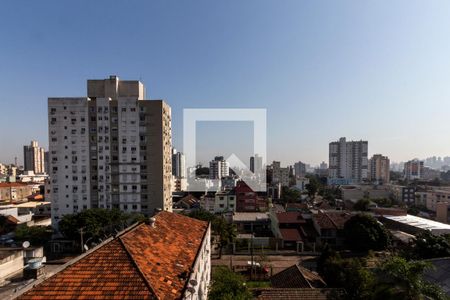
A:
[208,266,253,300]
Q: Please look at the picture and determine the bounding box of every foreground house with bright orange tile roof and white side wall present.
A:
[15,211,211,299]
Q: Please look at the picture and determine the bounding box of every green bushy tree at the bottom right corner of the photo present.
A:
[374,256,447,300]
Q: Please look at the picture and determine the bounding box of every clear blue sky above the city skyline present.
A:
[0,0,450,164]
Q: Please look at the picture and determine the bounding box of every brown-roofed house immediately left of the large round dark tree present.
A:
[312,210,353,247]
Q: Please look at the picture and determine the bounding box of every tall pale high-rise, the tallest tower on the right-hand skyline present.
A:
[328,137,368,182]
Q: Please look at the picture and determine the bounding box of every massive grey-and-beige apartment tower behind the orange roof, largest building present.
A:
[48,76,172,224]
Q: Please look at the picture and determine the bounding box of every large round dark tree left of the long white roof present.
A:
[344,214,390,252]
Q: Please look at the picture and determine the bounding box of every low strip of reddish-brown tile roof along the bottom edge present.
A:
[254,288,345,300]
